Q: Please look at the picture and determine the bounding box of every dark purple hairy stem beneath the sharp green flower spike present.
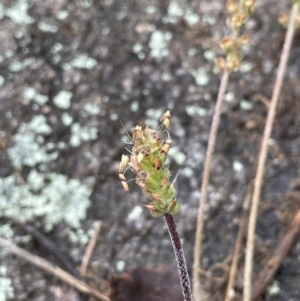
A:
[164,213,193,301]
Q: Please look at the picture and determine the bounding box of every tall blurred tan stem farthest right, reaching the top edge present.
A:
[243,1,299,301]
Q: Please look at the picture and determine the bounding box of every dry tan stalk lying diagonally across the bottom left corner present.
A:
[0,237,110,301]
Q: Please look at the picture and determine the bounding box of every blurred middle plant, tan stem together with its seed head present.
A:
[193,0,255,301]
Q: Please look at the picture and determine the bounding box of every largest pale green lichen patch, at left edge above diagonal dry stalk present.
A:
[0,170,91,230]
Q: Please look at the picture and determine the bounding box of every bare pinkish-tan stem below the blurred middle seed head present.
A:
[193,70,229,301]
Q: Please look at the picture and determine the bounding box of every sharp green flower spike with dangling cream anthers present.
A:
[119,111,179,216]
